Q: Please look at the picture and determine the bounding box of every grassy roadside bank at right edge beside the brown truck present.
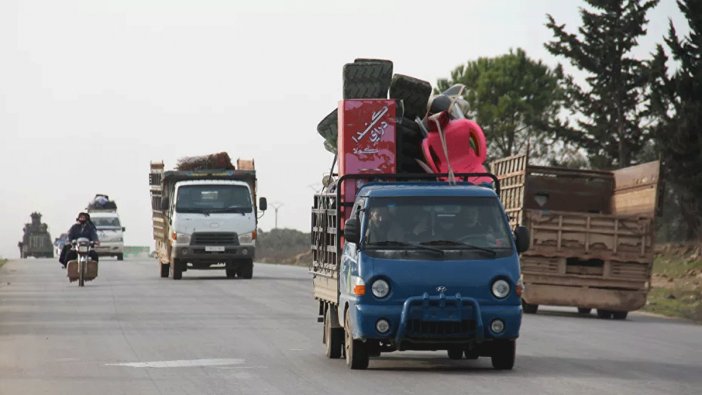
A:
[644,245,702,323]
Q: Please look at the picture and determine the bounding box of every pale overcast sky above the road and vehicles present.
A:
[0,0,687,257]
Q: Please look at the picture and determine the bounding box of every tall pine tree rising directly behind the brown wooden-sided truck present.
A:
[545,0,658,167]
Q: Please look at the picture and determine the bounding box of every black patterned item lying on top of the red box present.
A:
[343,59,392,99]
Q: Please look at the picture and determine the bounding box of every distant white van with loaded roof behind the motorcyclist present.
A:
[87,194,126,261]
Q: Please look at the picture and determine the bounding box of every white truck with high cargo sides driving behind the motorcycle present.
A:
[149,160,267,280]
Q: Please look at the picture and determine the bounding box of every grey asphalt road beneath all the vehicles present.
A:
[0,259,702,395]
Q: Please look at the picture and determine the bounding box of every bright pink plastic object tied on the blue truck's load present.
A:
[422,119,492,184]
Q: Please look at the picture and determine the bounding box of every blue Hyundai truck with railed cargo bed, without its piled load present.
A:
[311,173,529,369]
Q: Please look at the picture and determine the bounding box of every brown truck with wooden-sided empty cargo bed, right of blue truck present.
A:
[492,155,660,319]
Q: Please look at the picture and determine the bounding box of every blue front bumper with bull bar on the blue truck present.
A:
[351,294,522,350]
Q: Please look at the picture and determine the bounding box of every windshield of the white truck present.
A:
[176,185,253,214]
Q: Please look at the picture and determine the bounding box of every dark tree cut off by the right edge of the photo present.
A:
[649,0,702,240]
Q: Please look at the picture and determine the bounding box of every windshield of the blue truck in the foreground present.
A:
[363,196,512,257]
